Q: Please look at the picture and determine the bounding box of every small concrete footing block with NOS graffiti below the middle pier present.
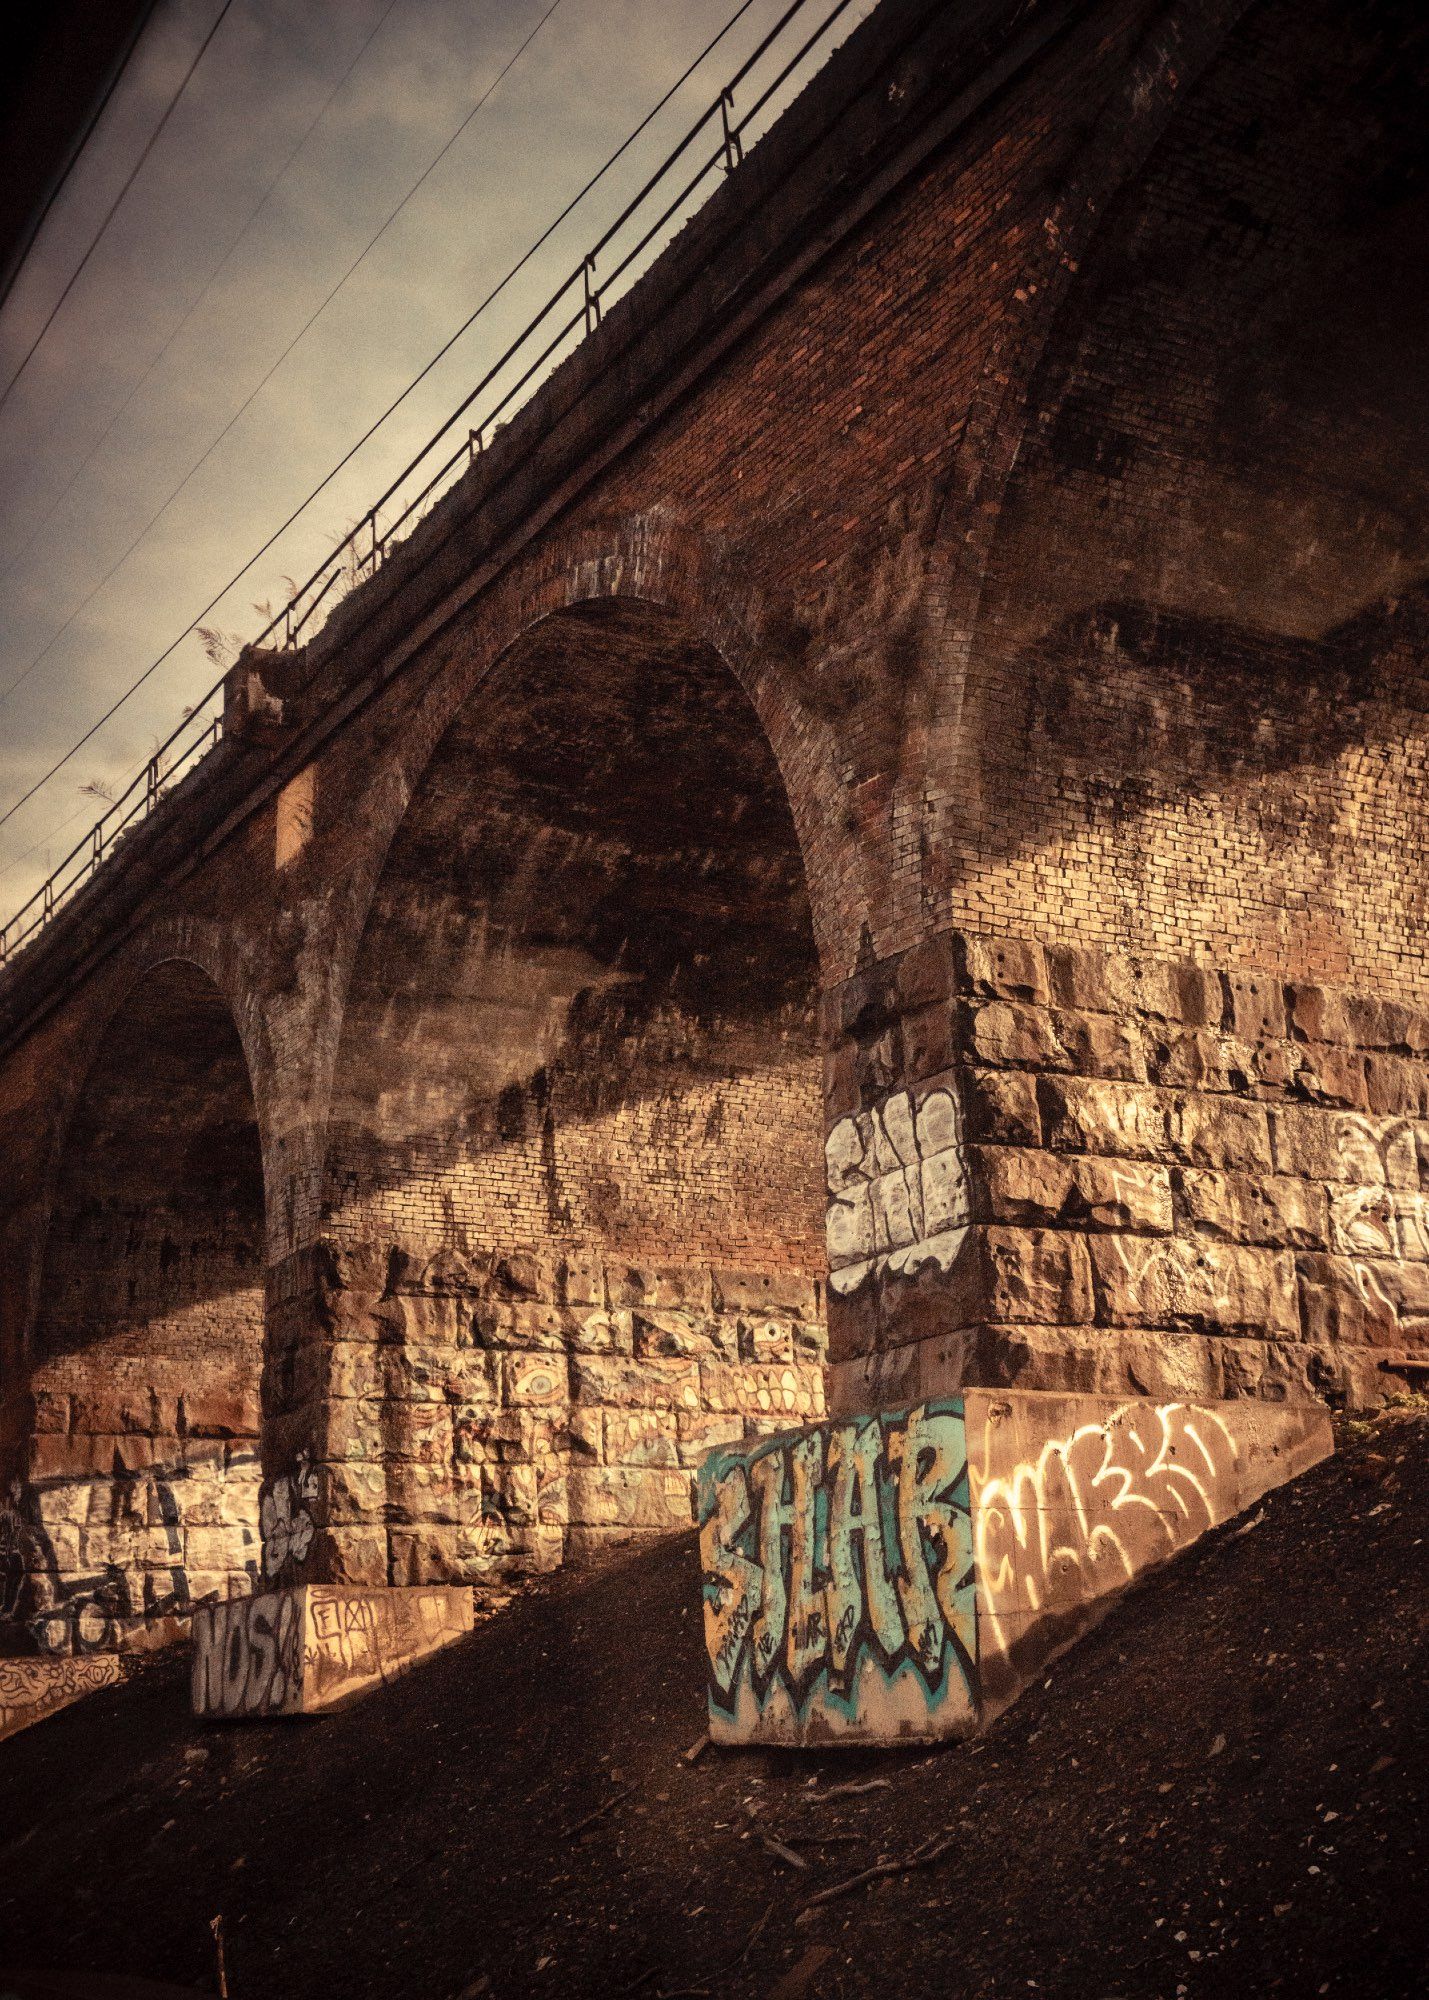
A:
[192,1584,472,1720]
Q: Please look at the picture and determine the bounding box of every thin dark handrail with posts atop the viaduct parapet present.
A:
[0,0,853,964]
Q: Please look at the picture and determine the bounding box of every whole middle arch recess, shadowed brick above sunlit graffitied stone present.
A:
[318,596,825,1582]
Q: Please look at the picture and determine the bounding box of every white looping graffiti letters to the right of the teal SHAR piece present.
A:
[973,1402,1237,1656]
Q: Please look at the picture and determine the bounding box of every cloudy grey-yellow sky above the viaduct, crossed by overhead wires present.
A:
[0,0,873,918]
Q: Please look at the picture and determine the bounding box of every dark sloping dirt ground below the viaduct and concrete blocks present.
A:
[0,1410,1429,2000]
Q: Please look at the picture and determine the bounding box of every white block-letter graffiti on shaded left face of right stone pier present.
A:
[825,1090,969,1292]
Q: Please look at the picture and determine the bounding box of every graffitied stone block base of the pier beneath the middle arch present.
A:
[264,1242,825,1584]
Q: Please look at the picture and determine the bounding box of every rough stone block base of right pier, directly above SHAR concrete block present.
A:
[827,934,1429,1410]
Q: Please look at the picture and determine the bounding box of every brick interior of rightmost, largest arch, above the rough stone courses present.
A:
[957,0,1429,996]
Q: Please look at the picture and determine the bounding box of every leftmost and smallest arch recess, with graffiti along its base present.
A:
[10,960,264,1652]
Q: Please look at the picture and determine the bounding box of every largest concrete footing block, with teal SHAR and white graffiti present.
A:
[698,1390,1333,1744]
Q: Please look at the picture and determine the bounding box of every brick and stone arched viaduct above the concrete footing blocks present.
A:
[0,0,1429,1650]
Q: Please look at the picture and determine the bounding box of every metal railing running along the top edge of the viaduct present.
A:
[0,0,855,964]
